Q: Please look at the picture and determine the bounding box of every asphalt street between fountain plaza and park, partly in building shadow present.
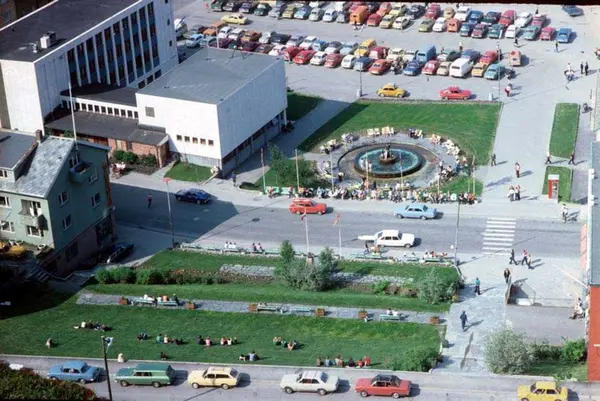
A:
[112,185,579,258]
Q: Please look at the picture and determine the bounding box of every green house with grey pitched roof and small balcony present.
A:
[0,130,114,276]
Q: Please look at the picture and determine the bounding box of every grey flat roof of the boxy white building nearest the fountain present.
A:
[138,47,283,104]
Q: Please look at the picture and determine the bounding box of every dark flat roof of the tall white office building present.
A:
[0,0,139,62]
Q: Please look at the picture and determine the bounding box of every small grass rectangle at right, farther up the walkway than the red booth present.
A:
[550,103,579,158]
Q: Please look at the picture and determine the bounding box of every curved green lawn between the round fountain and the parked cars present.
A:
[299,101,500,164]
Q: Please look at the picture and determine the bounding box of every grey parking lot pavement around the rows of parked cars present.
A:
[174,0,598,103]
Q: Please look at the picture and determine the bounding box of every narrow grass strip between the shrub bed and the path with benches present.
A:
[86,283,450,313]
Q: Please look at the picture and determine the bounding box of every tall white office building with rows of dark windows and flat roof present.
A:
[0,0,178,132]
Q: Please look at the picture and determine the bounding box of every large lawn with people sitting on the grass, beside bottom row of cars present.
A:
[0,287,440,367]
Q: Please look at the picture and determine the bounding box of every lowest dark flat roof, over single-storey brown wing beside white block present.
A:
[46,111,169,146]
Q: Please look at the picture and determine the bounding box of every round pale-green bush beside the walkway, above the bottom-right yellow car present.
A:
[484,329,533,374]
